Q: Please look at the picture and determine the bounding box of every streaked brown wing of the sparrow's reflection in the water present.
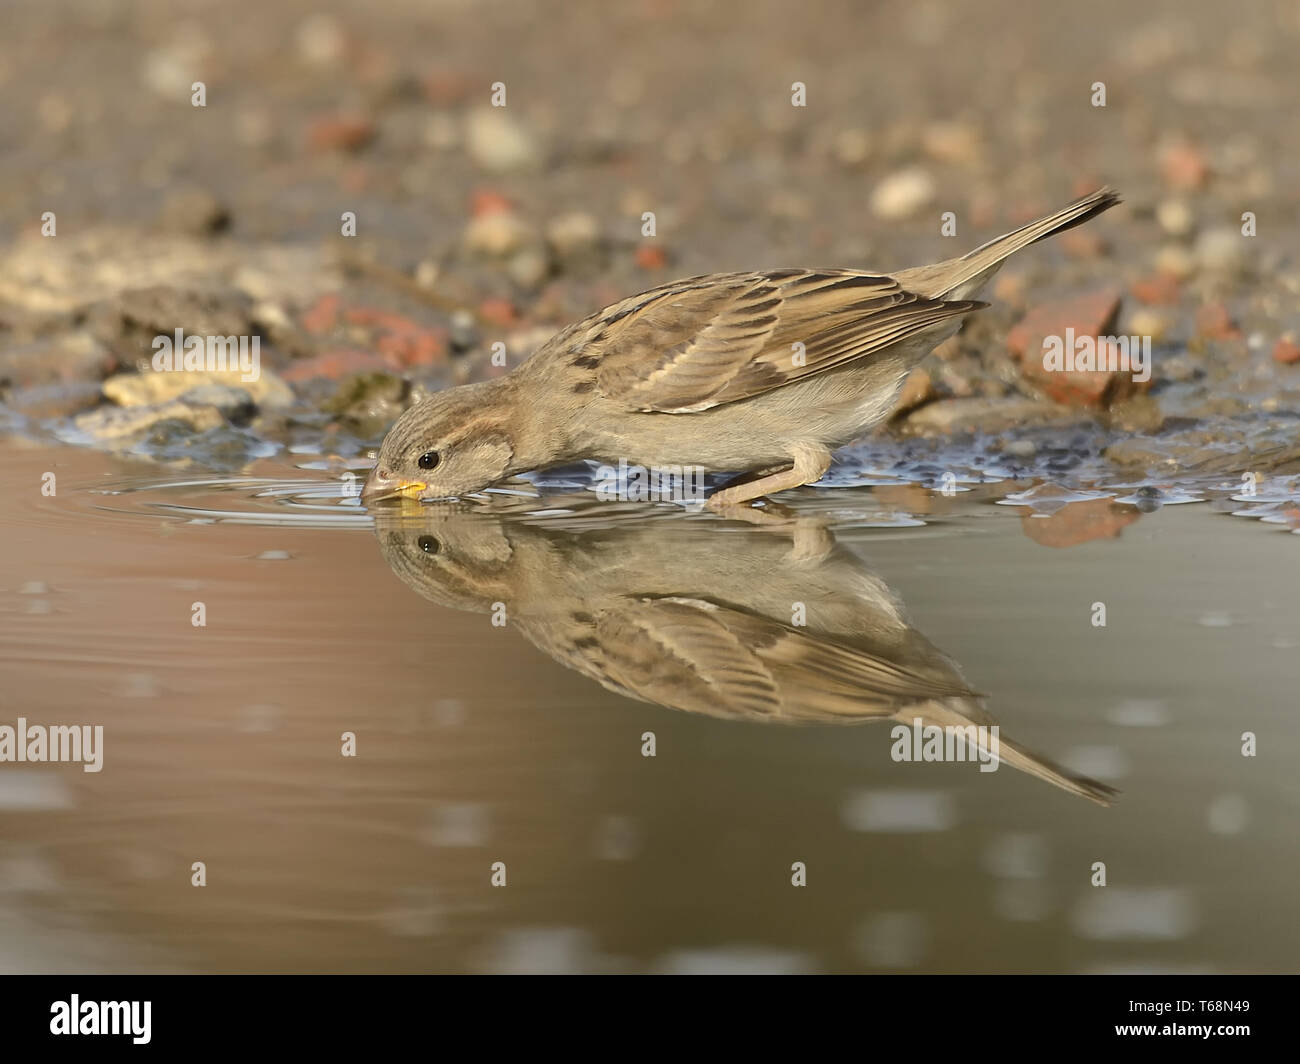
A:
[517,597,972,723]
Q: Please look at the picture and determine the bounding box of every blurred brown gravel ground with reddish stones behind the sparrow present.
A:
[0,0,1300,479]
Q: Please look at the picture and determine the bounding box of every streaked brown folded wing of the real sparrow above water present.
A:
[556,269,985,414]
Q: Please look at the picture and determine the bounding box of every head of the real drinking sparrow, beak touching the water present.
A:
[361,382,514,503]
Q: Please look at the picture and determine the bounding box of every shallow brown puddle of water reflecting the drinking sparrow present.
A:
[0,447,1300,972]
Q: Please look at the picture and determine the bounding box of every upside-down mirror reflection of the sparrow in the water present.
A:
[374,494,1114,805]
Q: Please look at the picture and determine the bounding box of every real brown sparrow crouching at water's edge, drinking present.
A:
[361,189,1119,510]
